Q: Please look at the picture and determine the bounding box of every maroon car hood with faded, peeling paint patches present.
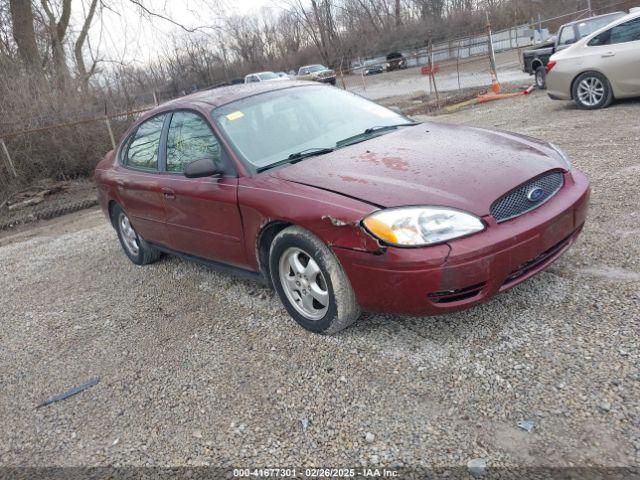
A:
[271,123,565,216]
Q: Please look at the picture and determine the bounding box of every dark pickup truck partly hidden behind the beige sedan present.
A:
[522,12,625,89]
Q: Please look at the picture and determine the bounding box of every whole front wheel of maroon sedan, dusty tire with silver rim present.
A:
[269,226,360,334]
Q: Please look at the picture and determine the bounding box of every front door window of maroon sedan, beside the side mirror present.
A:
[167,111,220,173]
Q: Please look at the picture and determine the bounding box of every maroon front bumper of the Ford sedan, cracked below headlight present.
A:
[334,170,590,315]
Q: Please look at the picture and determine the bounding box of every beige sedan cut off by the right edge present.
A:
[547,11,640,110]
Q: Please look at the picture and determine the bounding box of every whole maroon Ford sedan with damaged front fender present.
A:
[96,82,589,333]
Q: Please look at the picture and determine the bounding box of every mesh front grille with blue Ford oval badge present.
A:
[491,172,564,223]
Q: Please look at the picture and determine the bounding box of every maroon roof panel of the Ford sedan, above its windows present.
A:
[145,80,318,114]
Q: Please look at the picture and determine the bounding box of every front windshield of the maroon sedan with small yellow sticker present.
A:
[211,86,408,170]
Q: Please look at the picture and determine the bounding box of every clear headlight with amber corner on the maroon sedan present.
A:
[363,207,484,247]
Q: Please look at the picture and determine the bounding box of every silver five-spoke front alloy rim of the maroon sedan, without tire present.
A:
[279,247,329,320]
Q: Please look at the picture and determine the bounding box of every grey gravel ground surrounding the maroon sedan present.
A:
[0,93,640,469]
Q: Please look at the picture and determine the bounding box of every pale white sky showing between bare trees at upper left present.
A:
[72,0,279,65]
